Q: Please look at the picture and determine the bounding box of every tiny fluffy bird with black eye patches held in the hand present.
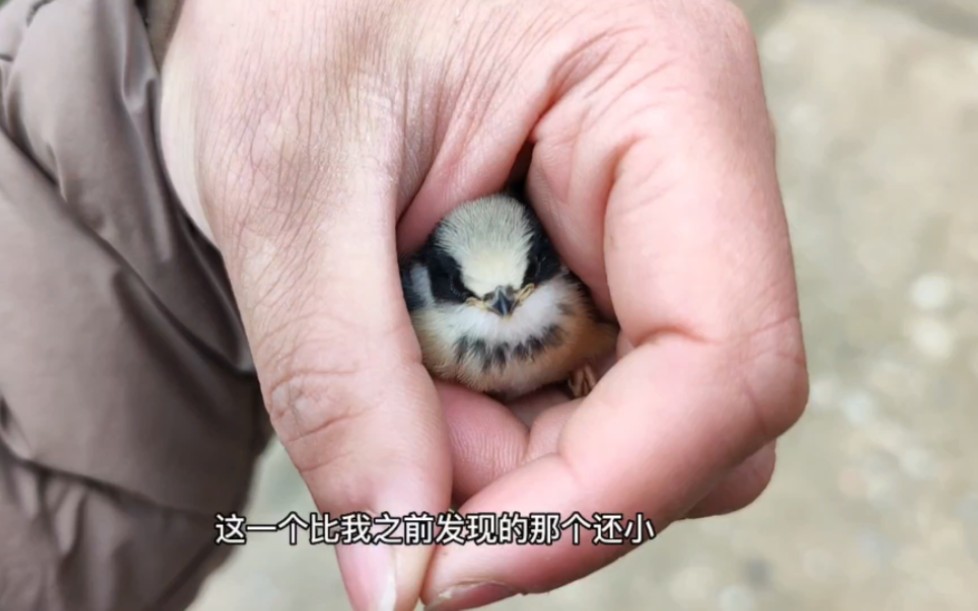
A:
[401,195,618,400]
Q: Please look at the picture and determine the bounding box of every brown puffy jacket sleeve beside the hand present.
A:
[0,0,268,610]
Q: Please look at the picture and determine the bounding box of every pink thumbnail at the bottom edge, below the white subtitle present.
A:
[336,545,397,611]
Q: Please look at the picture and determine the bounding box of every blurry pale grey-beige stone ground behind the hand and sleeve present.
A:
[187,0,978,611]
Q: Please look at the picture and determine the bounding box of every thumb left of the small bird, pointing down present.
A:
[248,189,451,609]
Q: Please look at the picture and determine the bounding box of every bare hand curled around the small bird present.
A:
[162,0,808,609]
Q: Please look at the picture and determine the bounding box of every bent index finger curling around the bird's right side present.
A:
[425,7,807,609]
